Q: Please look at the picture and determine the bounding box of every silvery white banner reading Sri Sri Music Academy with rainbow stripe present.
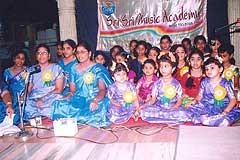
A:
[97,0,207,50]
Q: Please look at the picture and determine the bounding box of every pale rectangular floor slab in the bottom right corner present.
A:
[175,125,240,160]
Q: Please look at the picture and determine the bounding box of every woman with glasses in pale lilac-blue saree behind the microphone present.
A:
[25,44,64,118]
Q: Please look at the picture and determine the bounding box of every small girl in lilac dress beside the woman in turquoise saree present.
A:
[107,63,139,124]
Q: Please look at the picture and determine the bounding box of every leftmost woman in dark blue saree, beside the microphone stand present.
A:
[3,50,27,125]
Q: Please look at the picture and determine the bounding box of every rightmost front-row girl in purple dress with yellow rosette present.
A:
[190,58,240,126]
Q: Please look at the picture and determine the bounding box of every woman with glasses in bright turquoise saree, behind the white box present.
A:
[52,42,112,128]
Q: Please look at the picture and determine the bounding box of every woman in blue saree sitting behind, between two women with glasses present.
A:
[58,39,78,95]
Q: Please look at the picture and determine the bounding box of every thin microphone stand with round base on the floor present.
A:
[17,71,33,138]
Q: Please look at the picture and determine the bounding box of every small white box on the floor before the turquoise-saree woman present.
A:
[53,118,78,136]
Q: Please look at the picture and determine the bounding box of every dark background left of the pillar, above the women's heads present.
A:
[0,0,59,70]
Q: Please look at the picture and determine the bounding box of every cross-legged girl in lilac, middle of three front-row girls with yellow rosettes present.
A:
[140,54,189,124]
